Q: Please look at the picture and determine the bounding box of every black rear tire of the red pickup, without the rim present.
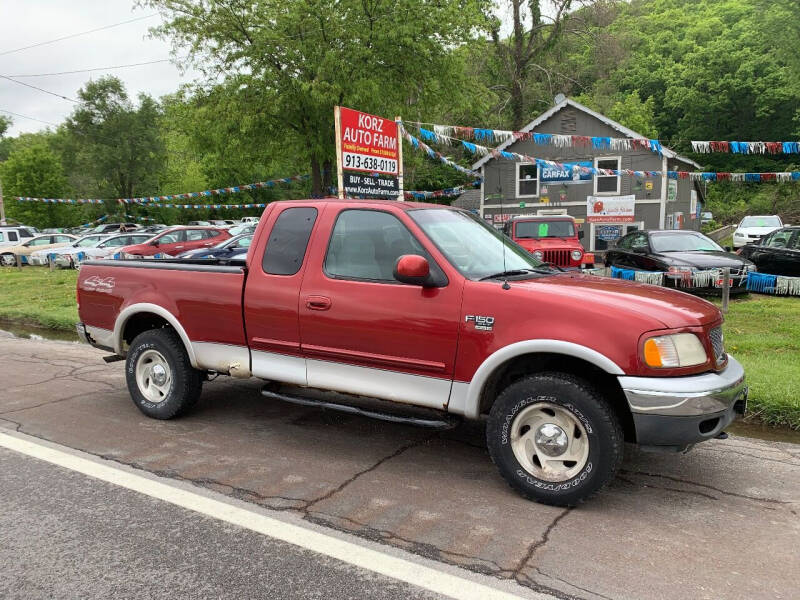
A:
[125,328,204,419]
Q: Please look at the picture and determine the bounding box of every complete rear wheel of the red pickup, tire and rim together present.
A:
[125,329,203,419]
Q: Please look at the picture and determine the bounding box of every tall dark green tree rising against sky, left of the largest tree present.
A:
[66,77,165,198]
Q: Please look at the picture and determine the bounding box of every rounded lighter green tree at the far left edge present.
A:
[0,142,74,227]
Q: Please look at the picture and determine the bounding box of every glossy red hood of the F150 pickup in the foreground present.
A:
[510,273,722,329]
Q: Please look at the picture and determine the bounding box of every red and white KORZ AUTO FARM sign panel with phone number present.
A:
[339,107,399,175]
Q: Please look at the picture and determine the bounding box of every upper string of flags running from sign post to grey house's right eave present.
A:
[411,121,664,156]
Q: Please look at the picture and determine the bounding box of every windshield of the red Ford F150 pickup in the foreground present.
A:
[408,208,544,279]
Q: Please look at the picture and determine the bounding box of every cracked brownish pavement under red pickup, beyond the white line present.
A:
[0,339,800,599]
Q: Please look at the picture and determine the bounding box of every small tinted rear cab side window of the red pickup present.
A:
[261,207,317,275]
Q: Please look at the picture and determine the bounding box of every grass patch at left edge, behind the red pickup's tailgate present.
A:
[0,267,78,330]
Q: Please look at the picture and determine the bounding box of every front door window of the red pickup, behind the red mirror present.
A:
[325,209,434,282]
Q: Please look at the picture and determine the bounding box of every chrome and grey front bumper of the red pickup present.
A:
[619,356,748,447]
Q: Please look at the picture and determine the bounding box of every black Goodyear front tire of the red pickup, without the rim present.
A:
[486,373,624,506]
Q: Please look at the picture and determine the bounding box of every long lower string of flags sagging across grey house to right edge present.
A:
[403,128,800,183]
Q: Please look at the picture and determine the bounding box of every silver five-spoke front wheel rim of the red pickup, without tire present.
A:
[511,402,589,482]
